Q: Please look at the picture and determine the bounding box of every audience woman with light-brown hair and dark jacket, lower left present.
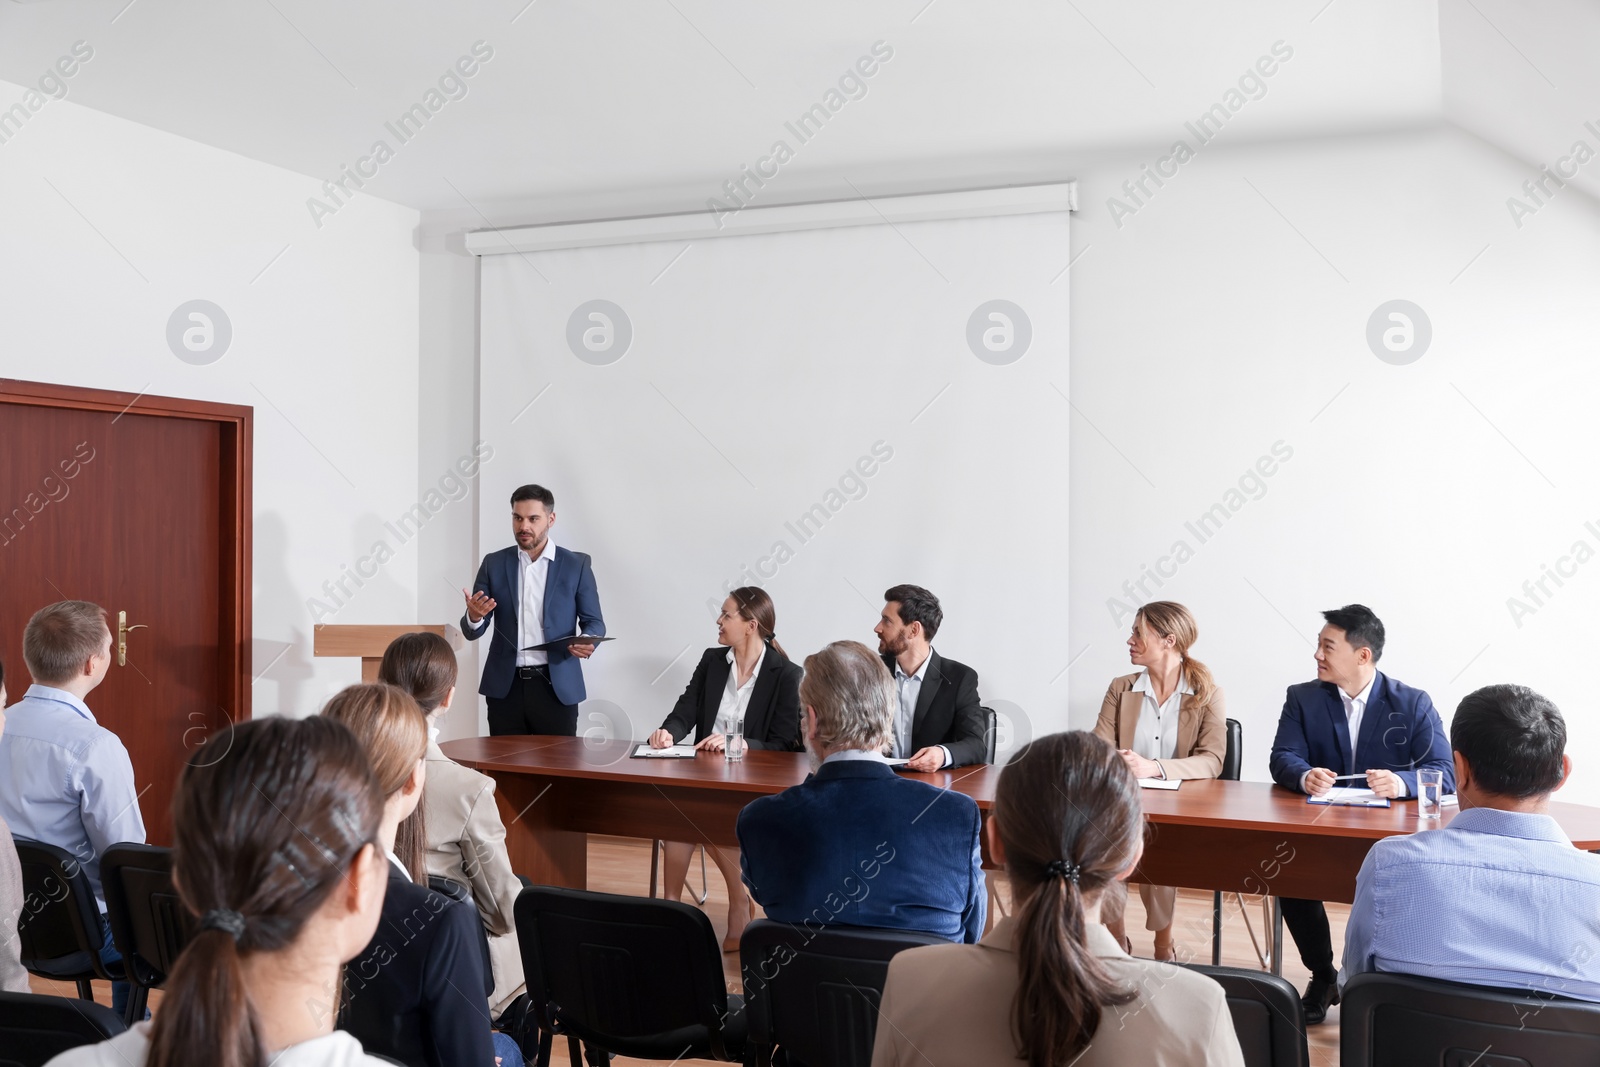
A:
[322,683,515,1067]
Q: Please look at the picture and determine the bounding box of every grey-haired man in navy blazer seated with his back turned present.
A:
[738,641,987,944]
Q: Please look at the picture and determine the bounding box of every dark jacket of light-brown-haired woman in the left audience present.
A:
[339,861,494,1067]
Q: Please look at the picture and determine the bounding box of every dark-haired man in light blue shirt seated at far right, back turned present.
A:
[1341,685,1600,1001]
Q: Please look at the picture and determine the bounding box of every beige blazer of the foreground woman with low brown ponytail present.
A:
[872,918,1245,1067]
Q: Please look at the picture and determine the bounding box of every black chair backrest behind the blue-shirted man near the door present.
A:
[16,837,122,981]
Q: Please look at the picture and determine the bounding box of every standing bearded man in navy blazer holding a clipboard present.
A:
[461,485,605,737]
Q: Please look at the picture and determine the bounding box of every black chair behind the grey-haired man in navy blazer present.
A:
[739,918,949,1067]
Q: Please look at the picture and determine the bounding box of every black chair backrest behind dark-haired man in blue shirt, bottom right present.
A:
[1339,973,1600,1067]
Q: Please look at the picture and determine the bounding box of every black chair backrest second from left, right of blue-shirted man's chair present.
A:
[101,843,195,989]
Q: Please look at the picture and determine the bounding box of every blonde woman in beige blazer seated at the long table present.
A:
[1094,600,1227,960]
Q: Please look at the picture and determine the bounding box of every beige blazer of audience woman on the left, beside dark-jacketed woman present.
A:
[422,742,525,1016]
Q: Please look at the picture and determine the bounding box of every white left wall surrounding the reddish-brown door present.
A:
[0,83,437,715]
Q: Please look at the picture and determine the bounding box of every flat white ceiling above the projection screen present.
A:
[0,0,1465,222]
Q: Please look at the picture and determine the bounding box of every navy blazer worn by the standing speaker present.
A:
[461,545,605,704]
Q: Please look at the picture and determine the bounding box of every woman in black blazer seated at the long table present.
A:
[650,585,802,952]
